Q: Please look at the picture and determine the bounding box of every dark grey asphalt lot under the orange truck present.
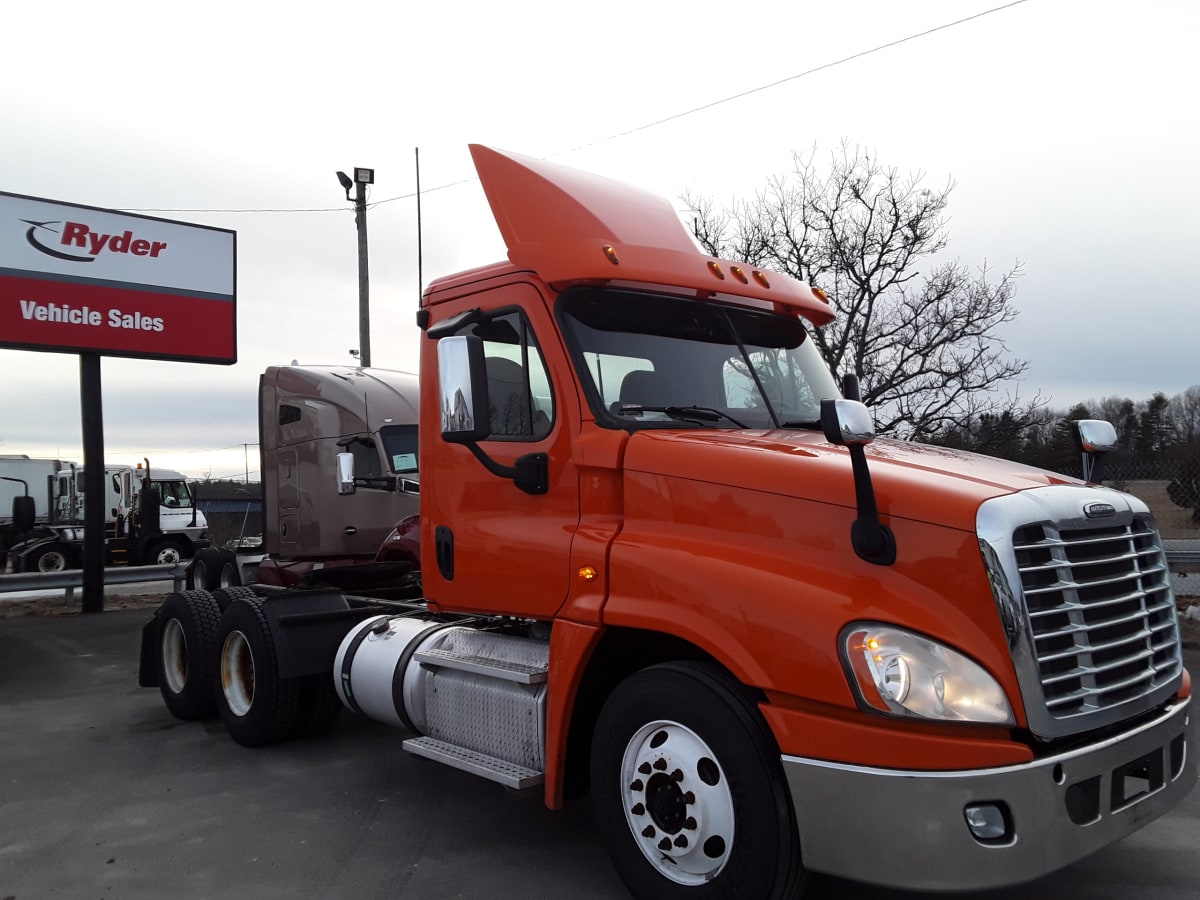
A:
[0,608,1200,900]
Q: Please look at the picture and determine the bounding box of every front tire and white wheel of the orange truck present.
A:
[592,661,805,900]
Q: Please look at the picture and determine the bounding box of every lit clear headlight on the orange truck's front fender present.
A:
[842,624,1015,725]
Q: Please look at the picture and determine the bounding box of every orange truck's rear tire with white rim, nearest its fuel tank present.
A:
[215,600,300,746]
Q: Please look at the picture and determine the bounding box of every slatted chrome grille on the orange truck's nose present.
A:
[1013,517,1182,719]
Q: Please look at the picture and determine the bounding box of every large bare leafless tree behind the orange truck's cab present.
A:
[684,143,1044,439]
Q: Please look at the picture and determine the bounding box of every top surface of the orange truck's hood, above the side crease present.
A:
[624,430,1081,532]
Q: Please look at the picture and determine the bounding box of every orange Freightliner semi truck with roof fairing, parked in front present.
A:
[142,146,1195,898]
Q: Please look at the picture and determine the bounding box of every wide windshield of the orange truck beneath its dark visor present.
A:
[562,288,841,428]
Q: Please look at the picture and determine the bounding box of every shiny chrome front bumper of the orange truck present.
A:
[782,700,1196,890]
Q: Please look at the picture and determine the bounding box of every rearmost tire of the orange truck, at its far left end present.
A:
[157,590,221,720]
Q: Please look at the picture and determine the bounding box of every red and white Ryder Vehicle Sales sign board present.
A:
[0,192,238,364]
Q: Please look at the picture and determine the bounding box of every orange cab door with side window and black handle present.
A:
[420,284,580,618]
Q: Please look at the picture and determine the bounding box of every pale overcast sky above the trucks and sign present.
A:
[0,0,1200,479]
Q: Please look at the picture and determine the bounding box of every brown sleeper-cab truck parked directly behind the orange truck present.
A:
[180,365,419,595]
